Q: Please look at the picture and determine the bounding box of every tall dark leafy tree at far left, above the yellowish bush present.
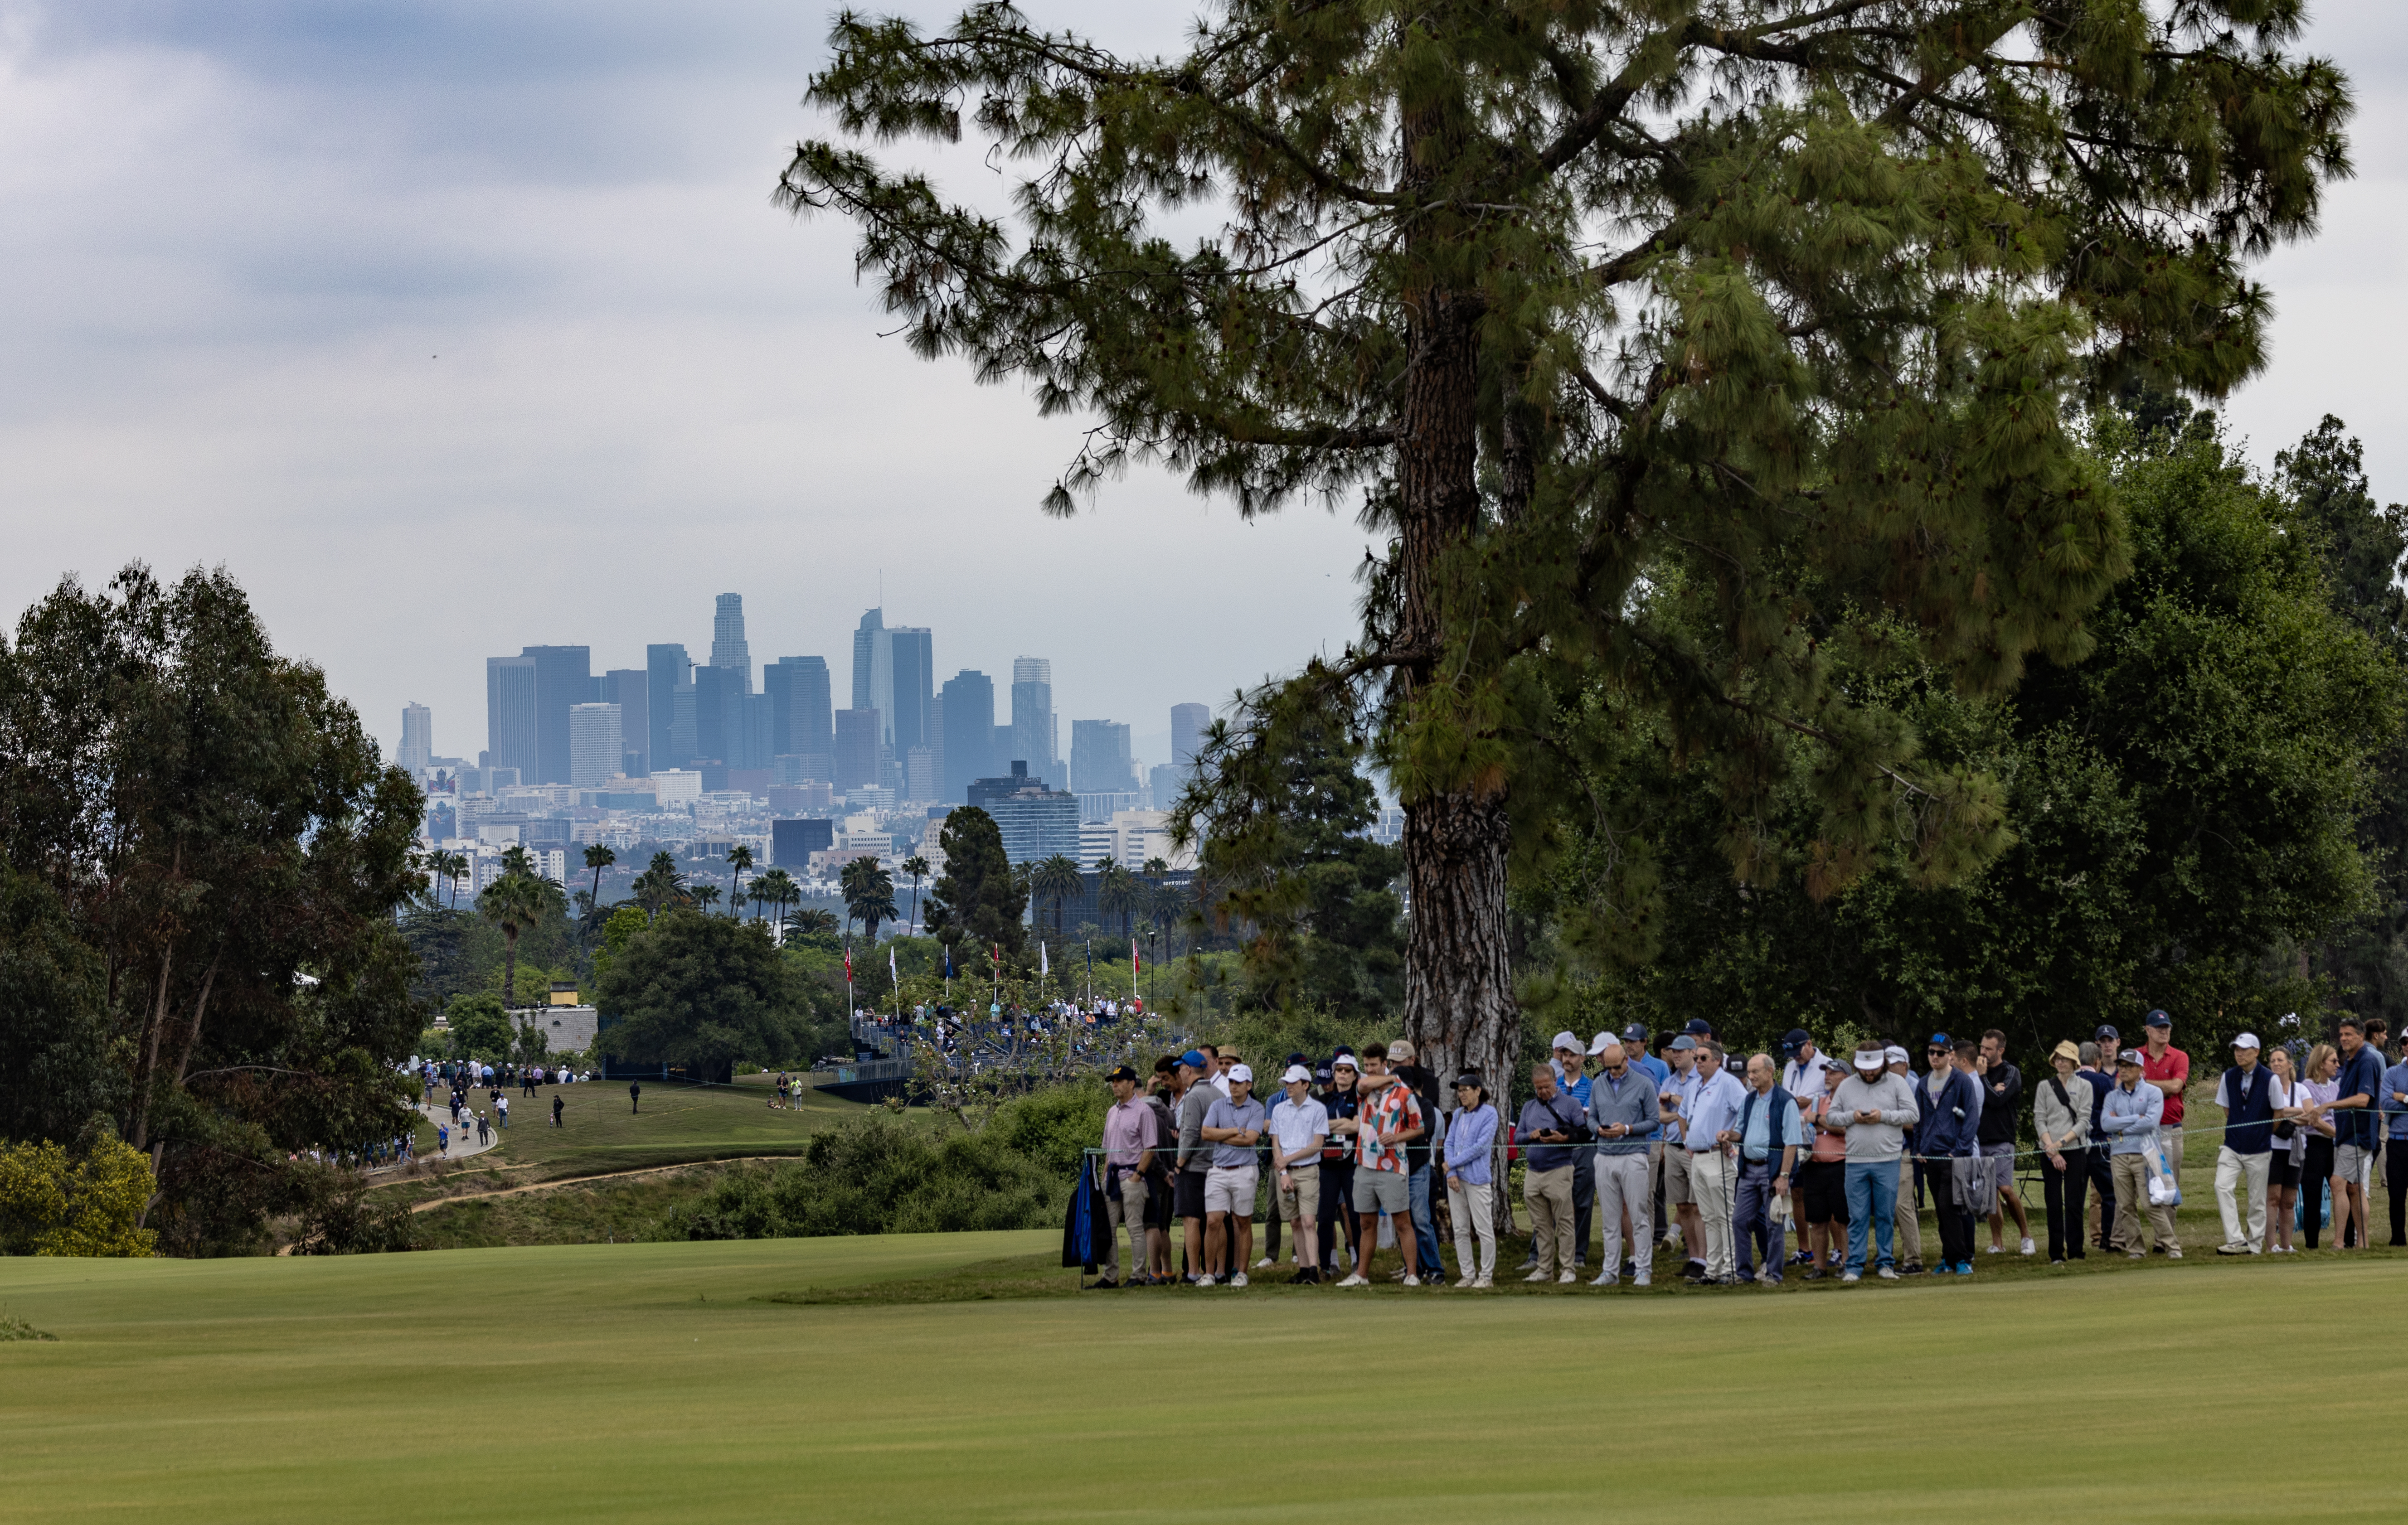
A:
[0,564,424,1255]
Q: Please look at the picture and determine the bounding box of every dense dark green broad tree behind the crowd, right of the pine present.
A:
[1524,419,2408,1067]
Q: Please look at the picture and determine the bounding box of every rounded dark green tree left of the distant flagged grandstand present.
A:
[595,910,809,1072]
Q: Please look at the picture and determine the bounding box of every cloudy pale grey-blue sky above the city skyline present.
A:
[0,0,2408,761]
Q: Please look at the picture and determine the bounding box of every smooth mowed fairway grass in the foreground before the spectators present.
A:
[0,1231,2408,1525]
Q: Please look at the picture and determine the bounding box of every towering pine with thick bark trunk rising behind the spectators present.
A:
[780,0,2350,1094]
